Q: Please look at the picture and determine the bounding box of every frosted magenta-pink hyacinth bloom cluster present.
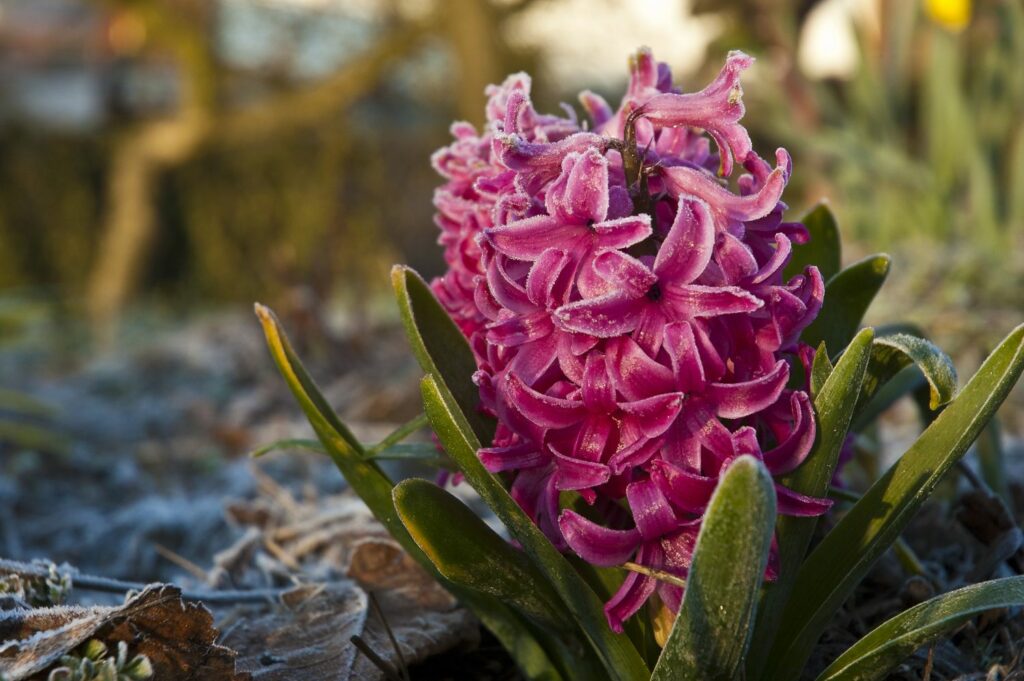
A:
[433,50,829,631]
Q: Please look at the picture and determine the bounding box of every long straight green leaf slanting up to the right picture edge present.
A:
[765,326,1024,679]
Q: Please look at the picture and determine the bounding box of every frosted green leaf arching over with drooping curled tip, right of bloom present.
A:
[860,333,956,411]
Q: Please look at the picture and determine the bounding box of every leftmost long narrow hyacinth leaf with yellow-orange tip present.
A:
[256,305,561,681]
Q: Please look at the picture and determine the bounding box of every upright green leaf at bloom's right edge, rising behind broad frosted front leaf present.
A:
[748,329,874,679]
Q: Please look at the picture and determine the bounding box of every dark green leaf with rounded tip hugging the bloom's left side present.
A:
[391,265,495,444]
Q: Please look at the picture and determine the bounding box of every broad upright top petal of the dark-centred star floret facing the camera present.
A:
[654,199,715,284]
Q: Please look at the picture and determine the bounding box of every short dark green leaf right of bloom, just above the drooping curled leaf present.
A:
[801,255,890,352]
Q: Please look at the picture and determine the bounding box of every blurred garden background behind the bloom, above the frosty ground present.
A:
[0,0,1024,364]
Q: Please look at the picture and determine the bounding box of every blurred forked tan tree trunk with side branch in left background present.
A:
[86,0,428,329]
